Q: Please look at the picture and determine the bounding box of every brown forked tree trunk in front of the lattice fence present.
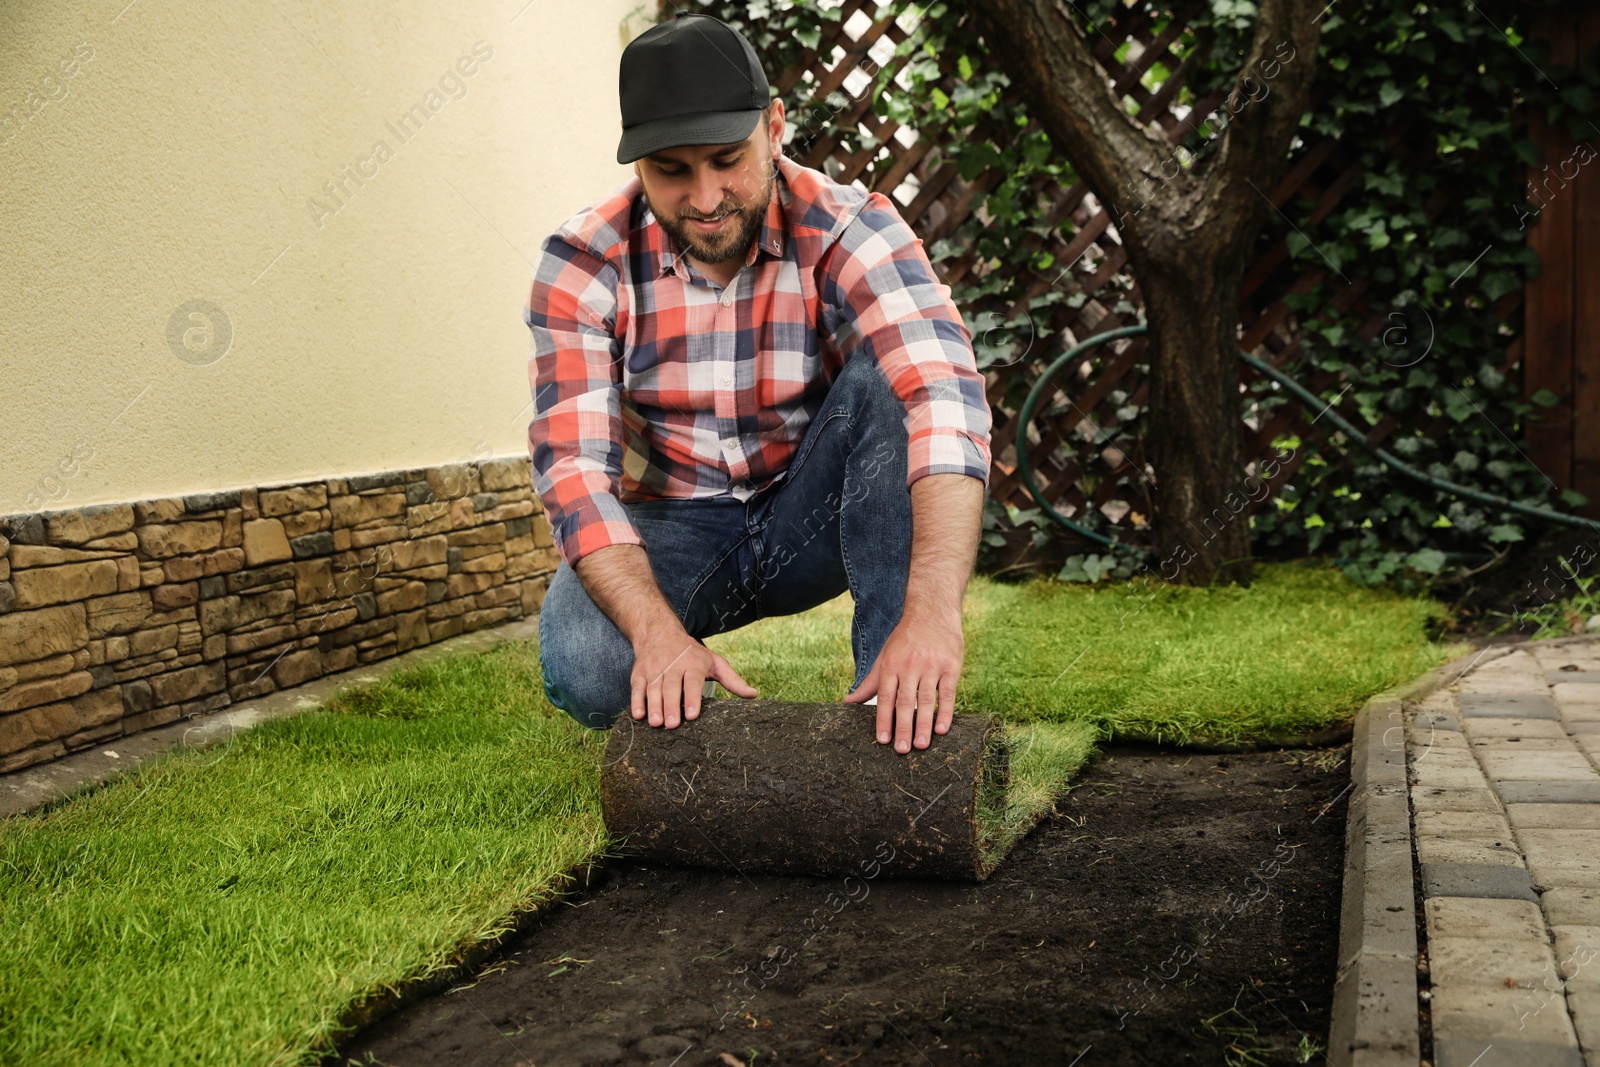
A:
[970,0,1325,585]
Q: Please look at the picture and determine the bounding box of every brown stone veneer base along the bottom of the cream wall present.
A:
[0,458,558,771]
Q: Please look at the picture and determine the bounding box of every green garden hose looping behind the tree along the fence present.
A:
[1016,323,1600,558]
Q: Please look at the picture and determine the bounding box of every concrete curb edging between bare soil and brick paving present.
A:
[1328,645,1520,1067]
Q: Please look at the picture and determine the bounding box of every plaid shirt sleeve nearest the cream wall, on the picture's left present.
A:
[525,234,645,566]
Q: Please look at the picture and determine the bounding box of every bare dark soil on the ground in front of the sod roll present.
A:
[331,745,1350,1067]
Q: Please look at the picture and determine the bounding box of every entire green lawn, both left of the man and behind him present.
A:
[0,566,1450,1067]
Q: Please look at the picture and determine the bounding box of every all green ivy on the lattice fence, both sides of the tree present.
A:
[681,0,1600,582]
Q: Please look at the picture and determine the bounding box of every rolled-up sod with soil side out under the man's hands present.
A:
[600,701,1088,881]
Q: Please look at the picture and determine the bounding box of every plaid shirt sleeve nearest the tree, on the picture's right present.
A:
[822,194,994,488]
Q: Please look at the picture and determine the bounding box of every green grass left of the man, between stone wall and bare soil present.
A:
[0,646,605,1067]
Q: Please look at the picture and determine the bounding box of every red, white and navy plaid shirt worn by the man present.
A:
[525,158,992,565]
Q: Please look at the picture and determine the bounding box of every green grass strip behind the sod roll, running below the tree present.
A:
[706,565,1461,744]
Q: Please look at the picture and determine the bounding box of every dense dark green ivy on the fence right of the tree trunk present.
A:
[1254,5,1600,581]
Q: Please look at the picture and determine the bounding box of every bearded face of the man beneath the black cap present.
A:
[634,102,784,264]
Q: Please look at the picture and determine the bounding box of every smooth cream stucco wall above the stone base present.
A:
[0,0,645,514]
